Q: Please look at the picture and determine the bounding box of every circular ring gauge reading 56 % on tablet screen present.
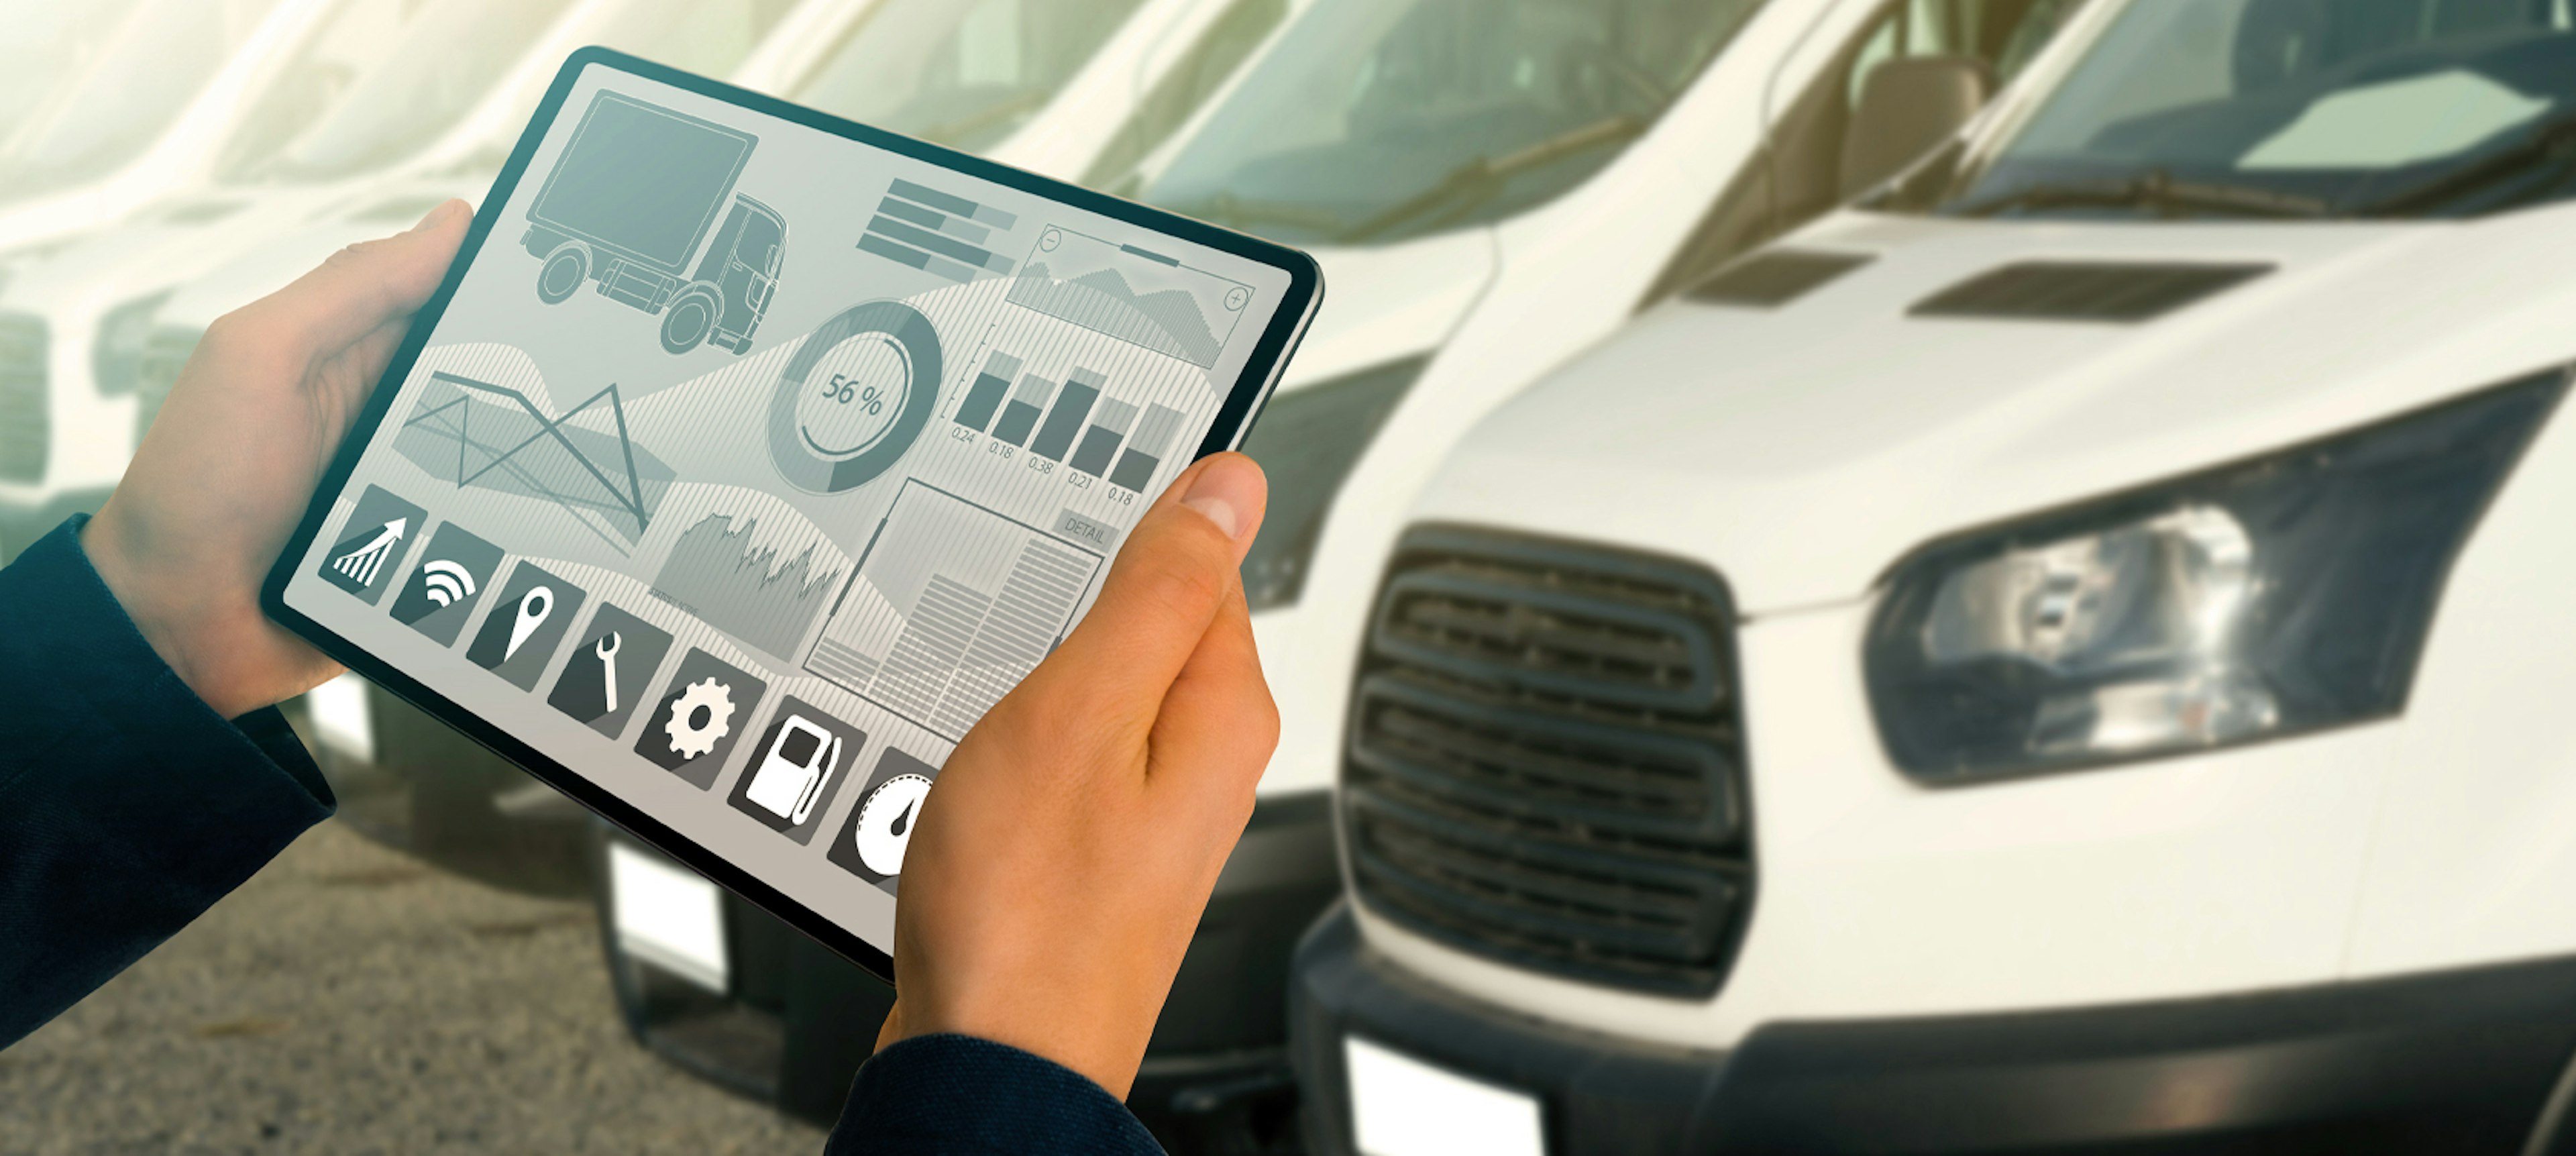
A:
[770,301,941,494]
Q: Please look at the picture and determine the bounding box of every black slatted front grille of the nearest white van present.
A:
[1342,528,1754,996]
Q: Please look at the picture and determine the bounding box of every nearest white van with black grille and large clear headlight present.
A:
[1293,0,2576,1156]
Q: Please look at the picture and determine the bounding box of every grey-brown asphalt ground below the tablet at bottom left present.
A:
[0,824,822,1156]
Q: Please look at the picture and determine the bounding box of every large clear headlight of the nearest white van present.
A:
[1862,371,2566,783]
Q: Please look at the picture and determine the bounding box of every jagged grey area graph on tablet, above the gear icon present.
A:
[652,513,845,657]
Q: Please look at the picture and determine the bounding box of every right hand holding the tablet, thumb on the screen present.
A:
[876,453,1280,1097]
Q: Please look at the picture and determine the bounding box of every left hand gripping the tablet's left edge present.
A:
[80,201,474,719]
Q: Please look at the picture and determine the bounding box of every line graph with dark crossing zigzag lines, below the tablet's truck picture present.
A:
[394,371,678,543]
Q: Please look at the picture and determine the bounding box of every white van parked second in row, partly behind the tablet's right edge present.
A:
[1110,0,2074,819]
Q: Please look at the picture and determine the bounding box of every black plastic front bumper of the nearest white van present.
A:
[1291,906,2576,1156]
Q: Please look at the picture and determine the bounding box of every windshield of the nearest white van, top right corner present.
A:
[1940,0,2576,219]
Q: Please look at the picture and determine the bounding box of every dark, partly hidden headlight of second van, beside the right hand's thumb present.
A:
[1244,358,1430,610]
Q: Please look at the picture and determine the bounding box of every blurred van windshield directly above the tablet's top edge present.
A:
[788,0,1141,152]
